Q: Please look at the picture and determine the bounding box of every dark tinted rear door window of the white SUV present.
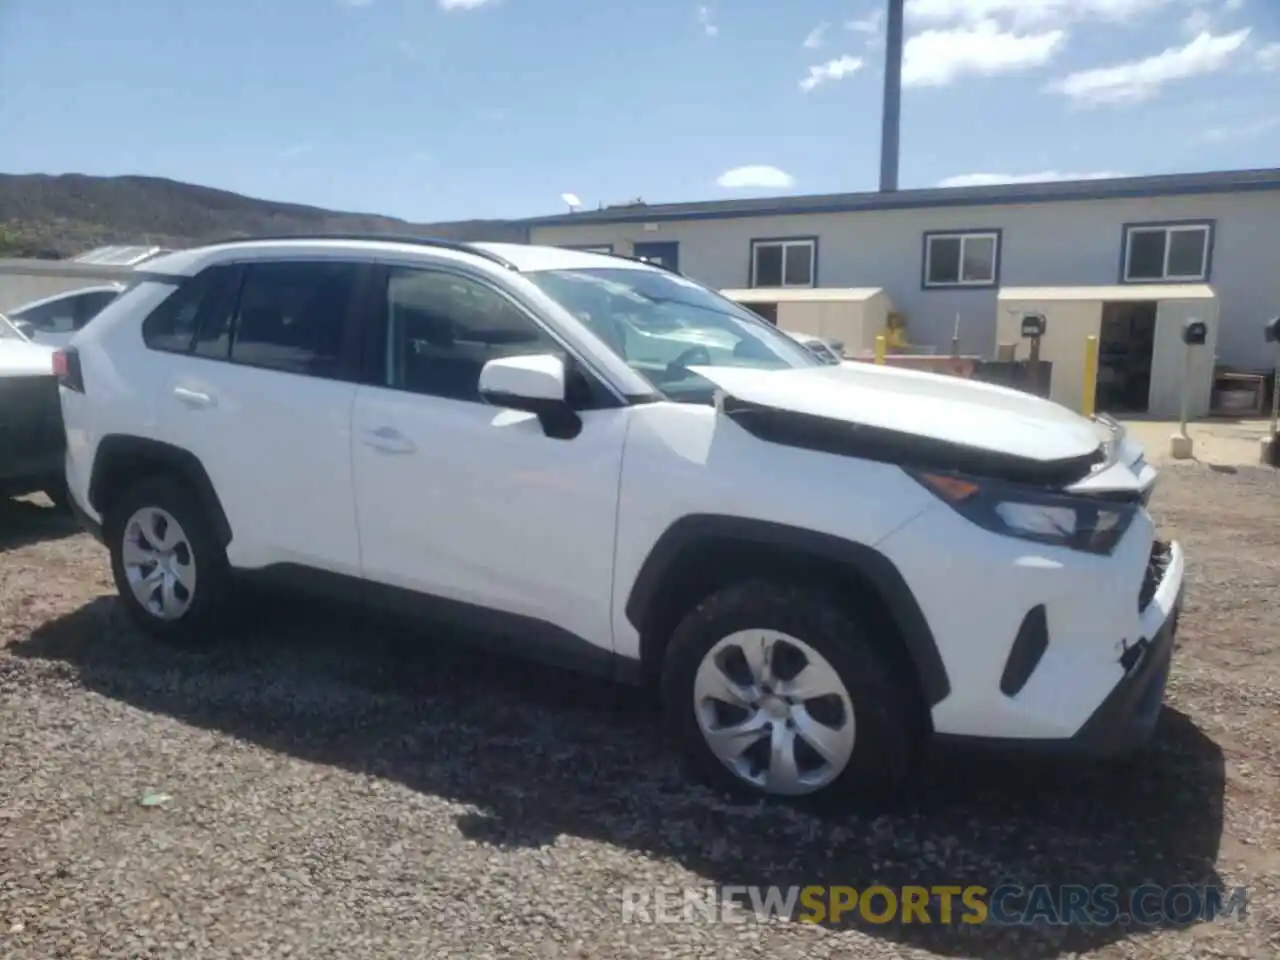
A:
[227,260,362,378]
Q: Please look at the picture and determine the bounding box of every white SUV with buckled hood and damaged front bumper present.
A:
[55,238,1183,803]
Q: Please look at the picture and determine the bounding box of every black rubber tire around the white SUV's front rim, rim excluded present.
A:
[662,580,920,812]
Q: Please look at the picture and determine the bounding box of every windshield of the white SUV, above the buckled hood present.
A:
[526,268,820,402]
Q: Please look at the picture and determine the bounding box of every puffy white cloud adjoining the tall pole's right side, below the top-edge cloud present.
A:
[902,20,1066,87]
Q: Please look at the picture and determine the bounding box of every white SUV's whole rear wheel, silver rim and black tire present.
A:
[104,476,229,645]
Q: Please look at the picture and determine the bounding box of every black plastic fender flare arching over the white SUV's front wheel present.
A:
[625,513,951,707]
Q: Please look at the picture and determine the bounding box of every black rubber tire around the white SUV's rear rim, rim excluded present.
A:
[102,476,232,648]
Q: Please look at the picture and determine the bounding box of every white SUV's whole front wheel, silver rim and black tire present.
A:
[662,581,916,809]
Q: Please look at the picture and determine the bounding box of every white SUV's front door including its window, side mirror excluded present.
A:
[352,259,630,655]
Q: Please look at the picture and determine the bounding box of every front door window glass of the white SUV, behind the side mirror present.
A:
[384,268,563,403]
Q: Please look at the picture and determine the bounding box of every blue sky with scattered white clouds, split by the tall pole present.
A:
[0,0,1280,220]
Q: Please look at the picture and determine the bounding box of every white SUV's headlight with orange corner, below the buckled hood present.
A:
[908,470,1139,554]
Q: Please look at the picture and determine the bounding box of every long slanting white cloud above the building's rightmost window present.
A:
[1050,27,1249,106]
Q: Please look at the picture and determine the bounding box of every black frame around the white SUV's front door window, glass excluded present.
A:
[360,260,630,410]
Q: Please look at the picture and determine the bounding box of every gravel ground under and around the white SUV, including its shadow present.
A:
[0,465,1280,960]
